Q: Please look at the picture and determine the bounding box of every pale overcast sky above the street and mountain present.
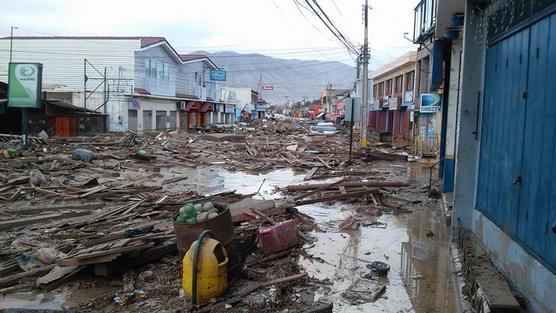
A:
[0,0,418,68]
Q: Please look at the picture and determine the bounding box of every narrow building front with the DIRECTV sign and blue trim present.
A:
[413,0,464,192]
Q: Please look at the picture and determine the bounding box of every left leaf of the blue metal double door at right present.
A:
[477,30,529,233]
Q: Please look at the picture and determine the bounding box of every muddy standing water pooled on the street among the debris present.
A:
[0,162,455,313]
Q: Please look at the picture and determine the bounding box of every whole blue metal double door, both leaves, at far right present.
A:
[476,14,556,271]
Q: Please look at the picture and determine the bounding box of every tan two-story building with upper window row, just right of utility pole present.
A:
[369,52,416,146]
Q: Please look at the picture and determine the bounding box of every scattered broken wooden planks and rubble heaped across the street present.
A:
[0,120,424,312]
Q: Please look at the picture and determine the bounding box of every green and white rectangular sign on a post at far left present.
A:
[8,63,42,108]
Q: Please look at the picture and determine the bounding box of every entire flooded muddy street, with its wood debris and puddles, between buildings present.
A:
[0,121,455,313]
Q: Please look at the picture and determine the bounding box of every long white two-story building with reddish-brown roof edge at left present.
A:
[0,37,232,131]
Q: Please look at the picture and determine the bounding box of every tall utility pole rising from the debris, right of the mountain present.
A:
[359,0,369,148]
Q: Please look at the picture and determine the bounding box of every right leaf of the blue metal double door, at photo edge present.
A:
[517,15,556,268]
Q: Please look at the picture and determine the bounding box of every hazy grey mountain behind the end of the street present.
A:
[201,51,355,104]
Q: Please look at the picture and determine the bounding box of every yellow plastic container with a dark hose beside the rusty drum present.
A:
[182,237,228,304]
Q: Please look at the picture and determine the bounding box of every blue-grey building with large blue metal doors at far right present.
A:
[452,0,556,312]
